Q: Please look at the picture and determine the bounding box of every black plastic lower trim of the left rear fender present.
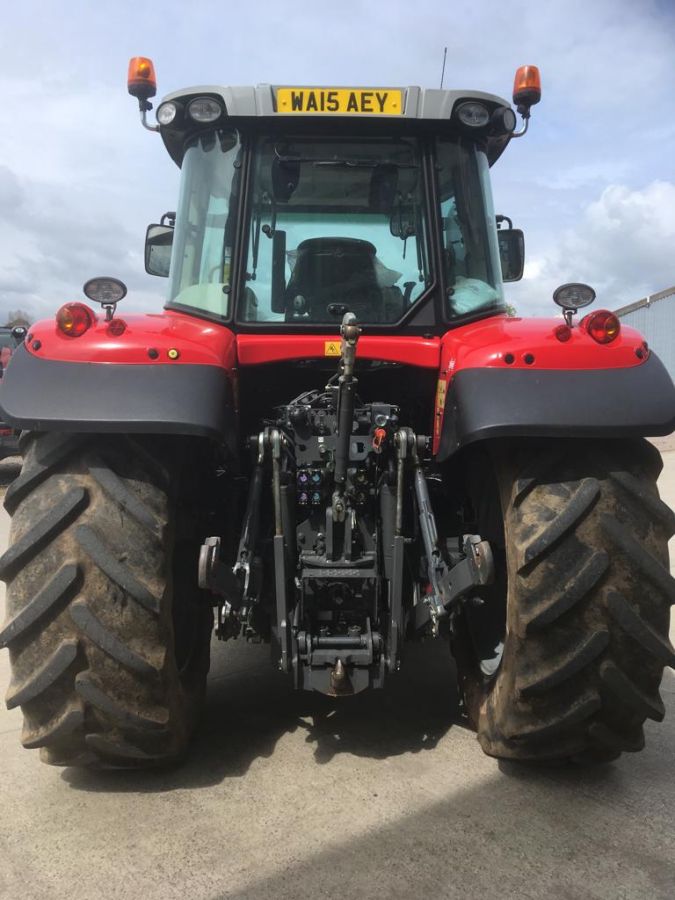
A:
[0,347,236,451]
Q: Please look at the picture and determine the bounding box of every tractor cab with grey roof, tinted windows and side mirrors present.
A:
[139,67,531,333]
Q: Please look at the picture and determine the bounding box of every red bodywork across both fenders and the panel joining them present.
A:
[26,311,647,452]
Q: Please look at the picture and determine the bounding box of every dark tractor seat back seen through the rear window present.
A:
[285,237,384,323]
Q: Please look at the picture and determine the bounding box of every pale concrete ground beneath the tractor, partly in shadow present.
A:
[0,451,675,900]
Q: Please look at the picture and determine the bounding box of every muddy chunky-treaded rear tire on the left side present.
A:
[0,433,212,768]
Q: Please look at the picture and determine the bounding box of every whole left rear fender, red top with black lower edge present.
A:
[0,315,236,450]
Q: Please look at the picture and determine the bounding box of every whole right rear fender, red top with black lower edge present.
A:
[434,320,675,461]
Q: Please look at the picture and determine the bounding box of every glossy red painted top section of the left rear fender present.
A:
[26,311,237,369]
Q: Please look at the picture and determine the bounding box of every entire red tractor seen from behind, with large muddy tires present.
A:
[0,58,675,767]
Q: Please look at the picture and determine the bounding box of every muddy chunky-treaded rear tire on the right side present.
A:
[454,440,675,762]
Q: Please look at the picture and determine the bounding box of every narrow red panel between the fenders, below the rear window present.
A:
[237,336,441,369]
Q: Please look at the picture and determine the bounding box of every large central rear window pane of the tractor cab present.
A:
[240,136,431,325]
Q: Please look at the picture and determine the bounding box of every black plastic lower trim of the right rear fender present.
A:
[437,354,675,461]
